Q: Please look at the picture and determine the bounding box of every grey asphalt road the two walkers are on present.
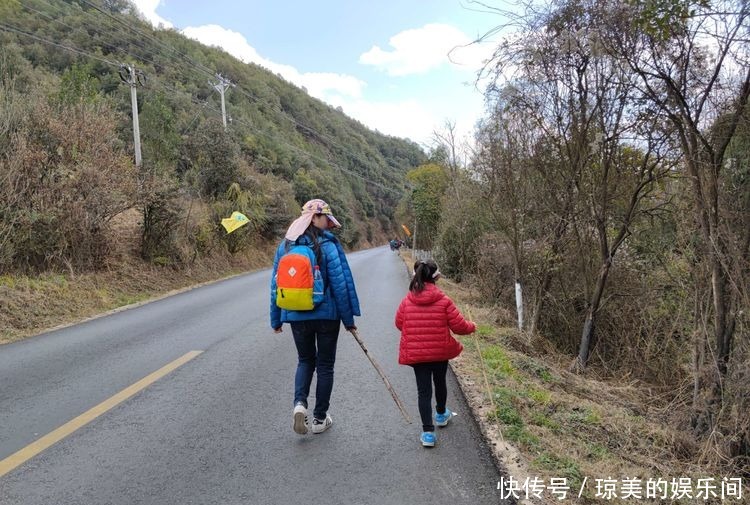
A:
[0,247,502,505]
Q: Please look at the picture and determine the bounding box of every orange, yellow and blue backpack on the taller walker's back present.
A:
[276,244,325,310]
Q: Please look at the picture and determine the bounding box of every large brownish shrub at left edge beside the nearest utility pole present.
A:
[0,94,137,271]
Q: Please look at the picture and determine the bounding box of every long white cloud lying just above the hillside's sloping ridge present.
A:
[182,25,365,100]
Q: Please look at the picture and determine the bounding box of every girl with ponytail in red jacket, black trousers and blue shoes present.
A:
[396,260,477,447]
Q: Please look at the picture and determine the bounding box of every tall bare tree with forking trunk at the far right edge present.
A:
[611,0,750,431]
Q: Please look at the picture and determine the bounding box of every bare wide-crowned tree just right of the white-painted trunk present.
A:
[478,2,680,370]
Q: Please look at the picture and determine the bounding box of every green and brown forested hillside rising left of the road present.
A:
[0,0,424,271]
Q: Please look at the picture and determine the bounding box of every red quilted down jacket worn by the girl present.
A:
[396,282,477,365]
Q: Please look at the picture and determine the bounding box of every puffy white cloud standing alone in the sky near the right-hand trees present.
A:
[359,23,492,76]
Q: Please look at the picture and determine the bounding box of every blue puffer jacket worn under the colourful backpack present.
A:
[270,231,361,329]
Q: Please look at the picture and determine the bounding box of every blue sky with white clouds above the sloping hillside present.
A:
[135,0,502,147]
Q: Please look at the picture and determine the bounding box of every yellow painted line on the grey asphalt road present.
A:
[0,351,203,477]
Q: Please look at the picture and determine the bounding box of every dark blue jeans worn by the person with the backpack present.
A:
[289,319,341,420]
